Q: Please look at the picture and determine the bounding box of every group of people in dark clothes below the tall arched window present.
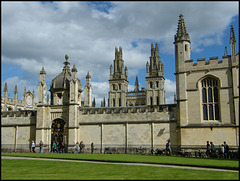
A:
[206,141,229,158]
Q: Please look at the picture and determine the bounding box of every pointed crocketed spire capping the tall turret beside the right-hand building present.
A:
[175,14,190,42]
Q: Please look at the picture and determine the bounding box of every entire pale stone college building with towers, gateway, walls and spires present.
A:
[1,15,239,153]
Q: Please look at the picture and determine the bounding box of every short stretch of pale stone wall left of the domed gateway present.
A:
[1,110,36,152]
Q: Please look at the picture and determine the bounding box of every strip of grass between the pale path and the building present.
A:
[1,153,239,168]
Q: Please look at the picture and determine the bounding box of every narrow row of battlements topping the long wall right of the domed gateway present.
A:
[80,104,176,115]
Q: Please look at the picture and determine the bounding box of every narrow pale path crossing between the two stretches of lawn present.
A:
[1,156,239,172]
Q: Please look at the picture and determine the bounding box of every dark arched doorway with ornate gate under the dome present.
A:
[51,119,67,151]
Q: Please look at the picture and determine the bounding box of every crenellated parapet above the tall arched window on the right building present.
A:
[185,55,231,71]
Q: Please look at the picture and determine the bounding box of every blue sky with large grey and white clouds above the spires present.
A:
[1,1,239,106]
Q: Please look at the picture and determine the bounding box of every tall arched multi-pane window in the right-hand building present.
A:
[202,77,220,120]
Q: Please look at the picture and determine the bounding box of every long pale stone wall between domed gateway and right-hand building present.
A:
[78,105,177,152]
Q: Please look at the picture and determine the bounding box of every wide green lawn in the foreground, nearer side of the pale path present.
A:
[1,158,239,180]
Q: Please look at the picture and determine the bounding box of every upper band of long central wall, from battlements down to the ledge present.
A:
[79,104,176,125]
